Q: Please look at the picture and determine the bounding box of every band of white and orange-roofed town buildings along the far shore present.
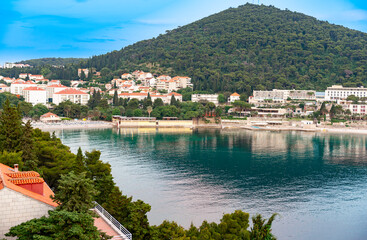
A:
[0,69,367,124]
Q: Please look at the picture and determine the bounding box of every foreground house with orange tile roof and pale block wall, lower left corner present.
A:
[0,163,57,239]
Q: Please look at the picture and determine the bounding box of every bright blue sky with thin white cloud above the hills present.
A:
[0,0,367,64]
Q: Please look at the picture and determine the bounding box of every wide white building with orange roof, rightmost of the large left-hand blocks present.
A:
[52,88,90,105]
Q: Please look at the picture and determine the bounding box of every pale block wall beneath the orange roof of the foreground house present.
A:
[0,187,54,239]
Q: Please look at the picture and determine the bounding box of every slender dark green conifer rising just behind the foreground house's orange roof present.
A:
[21,121,38,170]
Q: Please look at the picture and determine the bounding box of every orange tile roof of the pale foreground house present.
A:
[0,163,58,207]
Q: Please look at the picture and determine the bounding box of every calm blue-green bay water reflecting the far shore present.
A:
[56,129,367,240]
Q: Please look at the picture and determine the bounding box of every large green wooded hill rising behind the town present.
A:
[84,4,367,94]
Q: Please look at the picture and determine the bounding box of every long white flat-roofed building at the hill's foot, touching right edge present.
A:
[325,85,367,101]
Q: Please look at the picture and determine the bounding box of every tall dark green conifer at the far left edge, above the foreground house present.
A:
[0,99,23,152]
